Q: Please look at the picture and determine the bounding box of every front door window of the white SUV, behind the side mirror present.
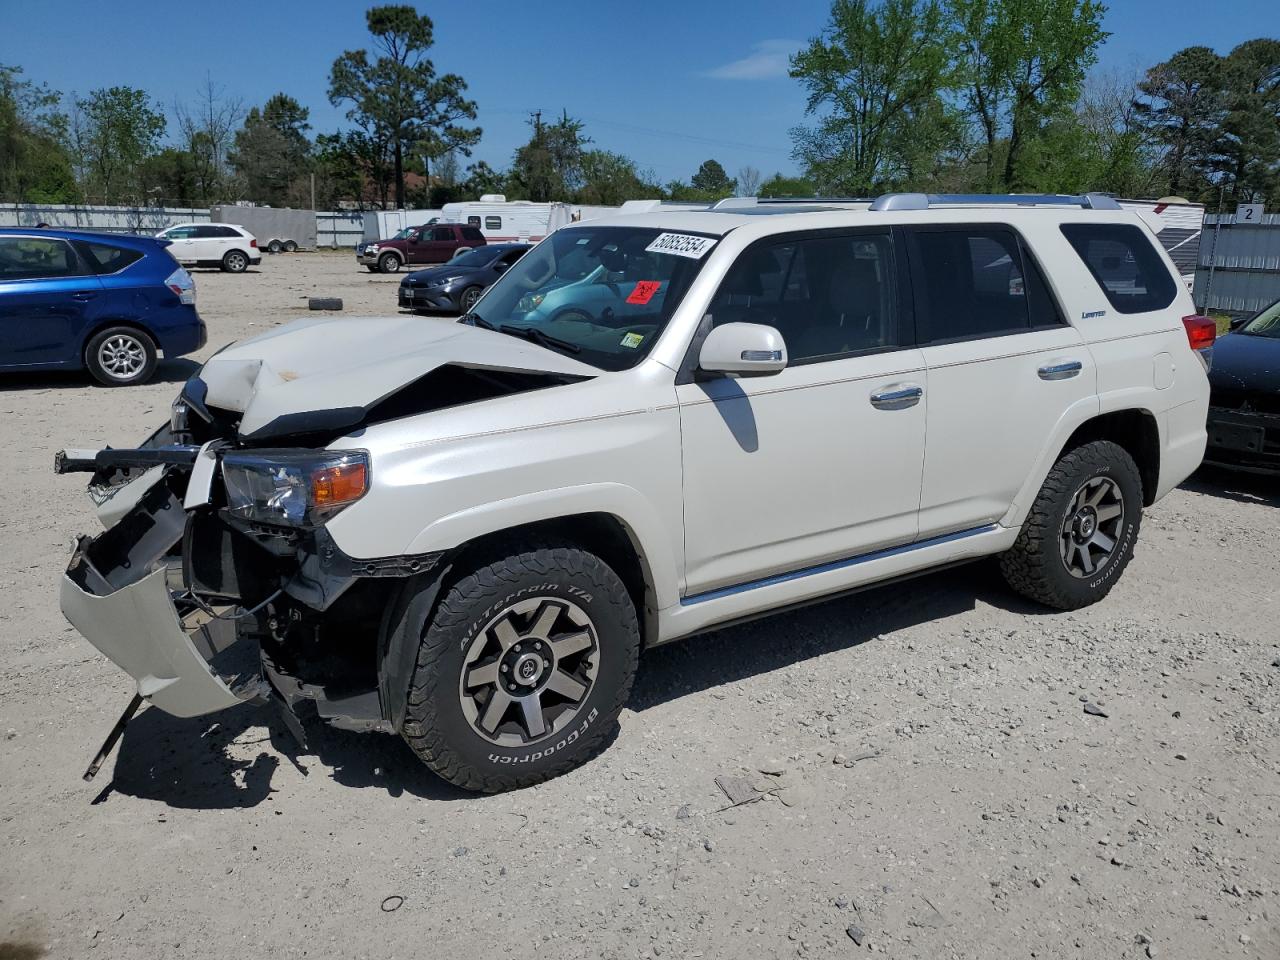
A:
[710,233,902,364]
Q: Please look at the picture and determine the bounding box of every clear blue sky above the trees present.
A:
[0,0,1280,180]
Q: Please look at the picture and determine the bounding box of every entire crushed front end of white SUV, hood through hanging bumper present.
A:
[55,319,590,778]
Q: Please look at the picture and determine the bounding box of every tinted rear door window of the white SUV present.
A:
[909,227,1064,343]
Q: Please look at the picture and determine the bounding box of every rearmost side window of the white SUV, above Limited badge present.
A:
[1061,223,1178,314]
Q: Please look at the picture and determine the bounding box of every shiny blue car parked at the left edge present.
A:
[0,228,206,387]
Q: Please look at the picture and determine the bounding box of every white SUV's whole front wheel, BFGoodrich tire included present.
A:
[401,545,640,792]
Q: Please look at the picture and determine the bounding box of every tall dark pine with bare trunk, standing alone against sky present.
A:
[329,5,480,206]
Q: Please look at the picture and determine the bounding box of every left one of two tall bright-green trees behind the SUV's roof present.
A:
[791,0,952,196]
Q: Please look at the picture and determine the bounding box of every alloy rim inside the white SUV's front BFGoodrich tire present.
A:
[458,596,600,746]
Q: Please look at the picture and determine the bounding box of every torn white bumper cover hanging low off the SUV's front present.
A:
[60,550,256,717]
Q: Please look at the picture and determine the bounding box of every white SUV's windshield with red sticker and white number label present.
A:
[471,227,716,370]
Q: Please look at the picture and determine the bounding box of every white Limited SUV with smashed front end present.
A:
[59,195,1213,791]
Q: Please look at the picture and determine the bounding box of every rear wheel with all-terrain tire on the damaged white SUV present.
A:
[1000,440,1142,611]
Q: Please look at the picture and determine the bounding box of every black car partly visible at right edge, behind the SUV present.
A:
[1204,300,1280,474]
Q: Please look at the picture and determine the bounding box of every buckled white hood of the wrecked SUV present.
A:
[200,316,600,439]
